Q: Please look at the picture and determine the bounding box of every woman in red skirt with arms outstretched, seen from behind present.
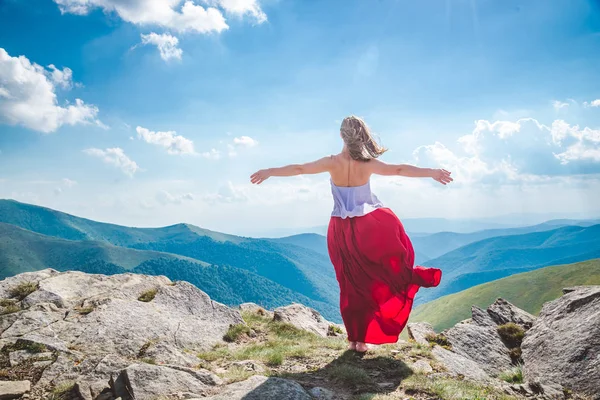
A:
[251,116,452,353]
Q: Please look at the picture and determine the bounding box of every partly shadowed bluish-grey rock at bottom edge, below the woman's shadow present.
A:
[203,375,312,400]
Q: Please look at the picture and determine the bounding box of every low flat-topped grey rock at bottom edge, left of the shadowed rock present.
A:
[115,364,220,400]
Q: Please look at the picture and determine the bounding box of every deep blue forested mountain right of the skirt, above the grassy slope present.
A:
[417,225,600,304]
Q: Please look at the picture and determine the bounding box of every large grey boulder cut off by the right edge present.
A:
[521,286,600,398]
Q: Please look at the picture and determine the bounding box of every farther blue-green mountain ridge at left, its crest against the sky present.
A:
[0,200,339,319]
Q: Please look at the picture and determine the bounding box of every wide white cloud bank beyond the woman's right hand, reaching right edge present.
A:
[414,118,600,184]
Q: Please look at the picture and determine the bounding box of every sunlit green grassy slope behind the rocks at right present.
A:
[410,259,600,332]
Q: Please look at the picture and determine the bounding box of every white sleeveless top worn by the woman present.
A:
[329,179,384,218]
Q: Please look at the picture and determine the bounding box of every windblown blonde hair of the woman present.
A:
[340,115,387,161]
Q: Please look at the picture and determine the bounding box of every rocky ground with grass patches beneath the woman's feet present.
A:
[0,270,600,400]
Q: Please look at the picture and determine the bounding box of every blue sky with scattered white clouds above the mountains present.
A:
[0,0,600,235]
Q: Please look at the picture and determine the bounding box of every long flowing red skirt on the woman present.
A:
[327,208,442,344]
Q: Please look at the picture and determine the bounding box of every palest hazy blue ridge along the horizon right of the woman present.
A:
[411,219,600,263]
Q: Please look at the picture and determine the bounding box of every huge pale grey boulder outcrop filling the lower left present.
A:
[0,269,244,399]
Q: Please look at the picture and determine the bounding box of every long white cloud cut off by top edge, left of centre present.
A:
[54,0,229,33]
